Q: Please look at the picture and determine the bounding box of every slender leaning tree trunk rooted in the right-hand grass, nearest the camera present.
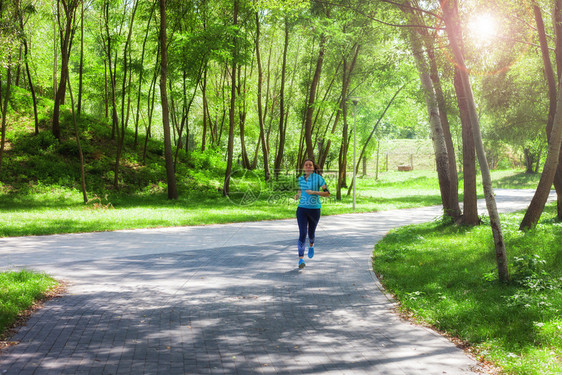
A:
[440,0,509,282]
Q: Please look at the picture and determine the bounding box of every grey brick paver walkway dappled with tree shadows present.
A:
[0,192,552,375]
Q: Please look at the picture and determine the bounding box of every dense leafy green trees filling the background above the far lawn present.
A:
[0,0,554,201]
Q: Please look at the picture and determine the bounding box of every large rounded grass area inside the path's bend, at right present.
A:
[374,205,562,375]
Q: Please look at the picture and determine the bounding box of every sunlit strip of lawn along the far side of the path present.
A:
[0,171,540,237]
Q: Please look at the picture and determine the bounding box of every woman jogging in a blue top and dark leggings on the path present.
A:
[295,159,330,268]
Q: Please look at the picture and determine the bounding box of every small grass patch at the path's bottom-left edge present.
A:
[0,270,57,339]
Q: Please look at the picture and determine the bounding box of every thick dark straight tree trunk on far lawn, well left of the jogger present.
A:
[160,0,178,199]
